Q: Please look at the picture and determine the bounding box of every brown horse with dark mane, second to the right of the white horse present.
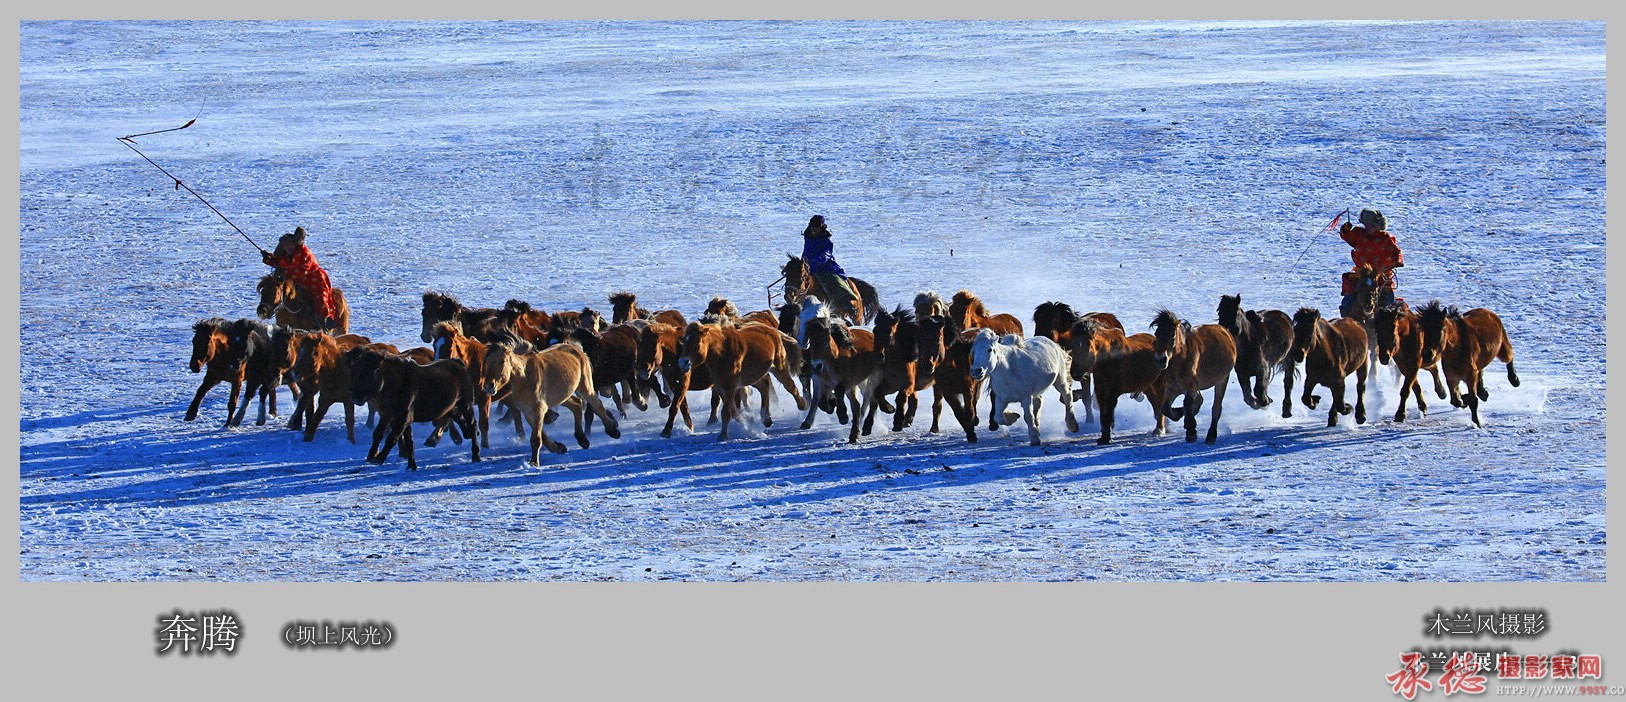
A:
[1151,310,1236,444]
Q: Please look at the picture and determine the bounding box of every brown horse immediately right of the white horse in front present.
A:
[1072,320,1166,444]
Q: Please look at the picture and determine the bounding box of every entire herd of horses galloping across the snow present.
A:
[185,257,1519,468]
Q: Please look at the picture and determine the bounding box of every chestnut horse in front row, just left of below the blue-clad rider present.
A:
[678,322,806,440]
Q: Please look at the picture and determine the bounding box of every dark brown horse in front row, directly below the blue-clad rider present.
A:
[802,315,881,444]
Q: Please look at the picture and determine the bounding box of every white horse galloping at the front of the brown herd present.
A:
[971,328,1078,445]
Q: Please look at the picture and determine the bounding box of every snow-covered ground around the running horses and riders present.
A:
[18,21,1606,580]
